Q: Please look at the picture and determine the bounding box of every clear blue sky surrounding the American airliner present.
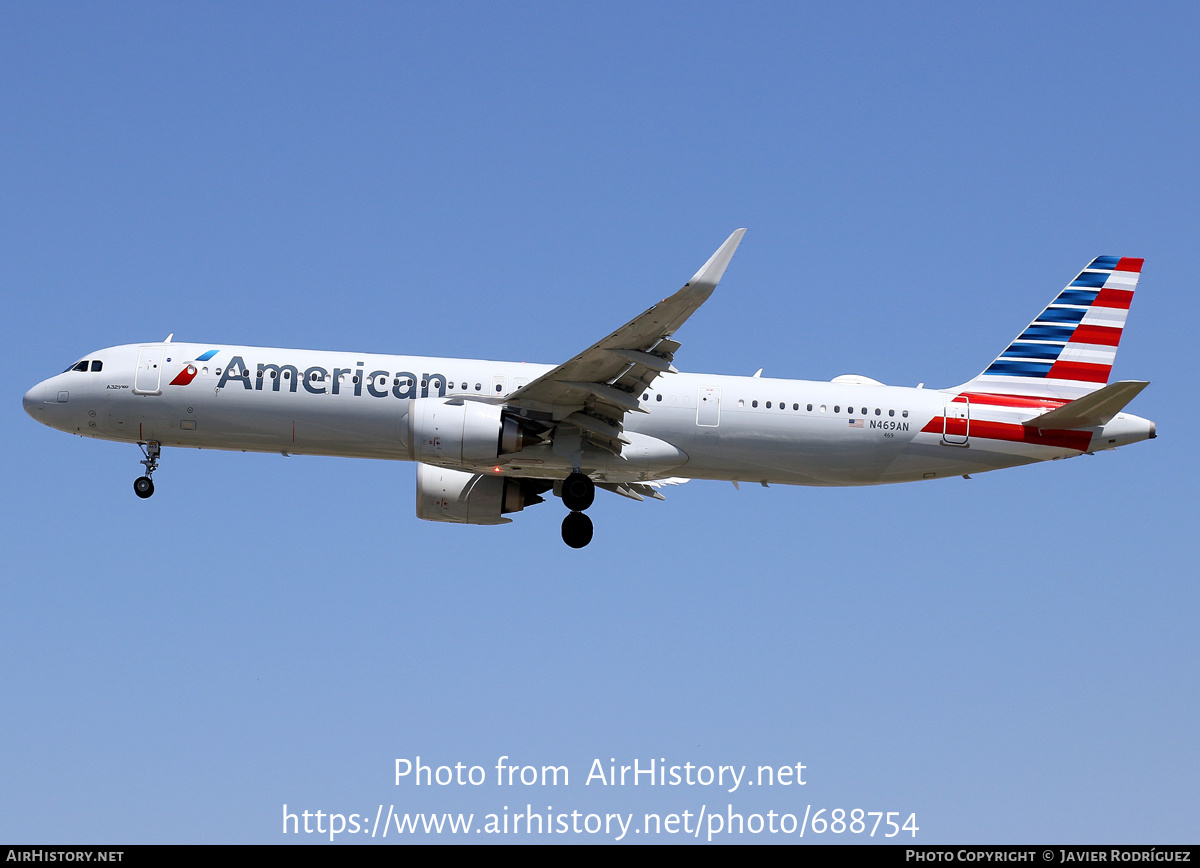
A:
[0,4,1200,843]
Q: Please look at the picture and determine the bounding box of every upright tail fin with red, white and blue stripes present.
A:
[959,256,1142,401]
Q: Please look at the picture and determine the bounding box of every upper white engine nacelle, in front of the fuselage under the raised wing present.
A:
[408,397,539,463]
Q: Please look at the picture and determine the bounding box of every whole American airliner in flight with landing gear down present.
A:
[24,229,1157,549]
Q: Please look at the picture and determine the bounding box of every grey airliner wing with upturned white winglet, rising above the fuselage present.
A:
[508,229,745,455]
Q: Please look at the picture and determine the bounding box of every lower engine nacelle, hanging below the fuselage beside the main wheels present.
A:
[416,463,551,525]
